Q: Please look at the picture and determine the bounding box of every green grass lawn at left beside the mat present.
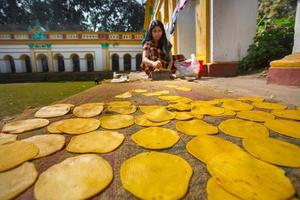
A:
[0,81,94,119]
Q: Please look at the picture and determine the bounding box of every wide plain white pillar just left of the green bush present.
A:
[210,0,258,62]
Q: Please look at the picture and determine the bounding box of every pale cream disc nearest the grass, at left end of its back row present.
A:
[34,104,74,118]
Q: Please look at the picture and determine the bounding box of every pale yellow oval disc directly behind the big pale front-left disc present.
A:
[67,131,125,153]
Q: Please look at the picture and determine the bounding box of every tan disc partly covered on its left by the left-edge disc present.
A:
[23,134,65,158]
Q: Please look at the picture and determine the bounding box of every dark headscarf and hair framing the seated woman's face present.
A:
[142,20,172,59]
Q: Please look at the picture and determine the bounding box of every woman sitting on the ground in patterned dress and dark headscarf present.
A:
[141,20,175,75]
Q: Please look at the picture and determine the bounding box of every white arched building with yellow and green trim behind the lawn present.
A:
[0,24,144,73]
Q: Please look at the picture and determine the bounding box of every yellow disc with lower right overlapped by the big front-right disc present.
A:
[186,135,243,163]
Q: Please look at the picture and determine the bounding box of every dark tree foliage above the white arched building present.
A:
[0,0,145,31]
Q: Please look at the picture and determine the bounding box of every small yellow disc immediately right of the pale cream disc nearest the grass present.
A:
[73,103,104,118]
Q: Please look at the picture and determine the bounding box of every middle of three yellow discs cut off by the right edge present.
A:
[264,119,300,139]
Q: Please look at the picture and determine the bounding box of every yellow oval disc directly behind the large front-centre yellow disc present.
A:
[131,127,180,149]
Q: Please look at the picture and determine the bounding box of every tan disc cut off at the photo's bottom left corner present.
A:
[0,162,38,199]
